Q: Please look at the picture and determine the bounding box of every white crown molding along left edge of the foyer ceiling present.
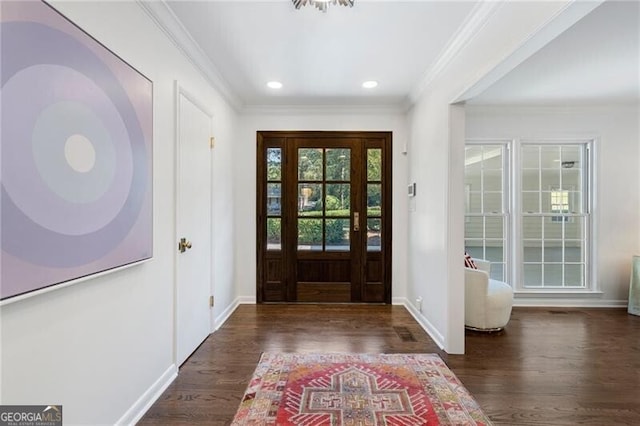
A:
[136,0,243,111]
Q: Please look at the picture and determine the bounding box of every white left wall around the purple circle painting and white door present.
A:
[0,1,236,425]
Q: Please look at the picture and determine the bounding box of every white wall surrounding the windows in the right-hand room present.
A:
[466,105,640,306]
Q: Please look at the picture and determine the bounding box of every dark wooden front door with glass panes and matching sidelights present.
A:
[257,132,391,303]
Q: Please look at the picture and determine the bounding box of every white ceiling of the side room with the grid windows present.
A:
[470,0,640,105]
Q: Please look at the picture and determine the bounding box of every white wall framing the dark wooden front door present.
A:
[234,107,407,301]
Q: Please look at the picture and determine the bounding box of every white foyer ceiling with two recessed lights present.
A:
[167,0,477,105]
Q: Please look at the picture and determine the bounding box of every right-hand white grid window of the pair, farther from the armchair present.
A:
[517,141,591,289]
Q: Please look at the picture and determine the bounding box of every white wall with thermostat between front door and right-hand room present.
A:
[407,1,587,353]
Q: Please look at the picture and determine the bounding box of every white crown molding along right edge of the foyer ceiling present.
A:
[409,1,502,104]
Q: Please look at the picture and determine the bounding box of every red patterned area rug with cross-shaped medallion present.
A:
[232,353,491,426]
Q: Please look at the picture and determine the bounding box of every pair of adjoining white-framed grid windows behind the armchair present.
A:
[465,140,592,292]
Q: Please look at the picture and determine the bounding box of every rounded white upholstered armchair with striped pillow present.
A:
[464,259,513,331]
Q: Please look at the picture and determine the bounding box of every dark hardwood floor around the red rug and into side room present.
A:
[139,305,640,426]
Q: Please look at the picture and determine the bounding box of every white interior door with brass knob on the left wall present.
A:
[175,85,212,366]
